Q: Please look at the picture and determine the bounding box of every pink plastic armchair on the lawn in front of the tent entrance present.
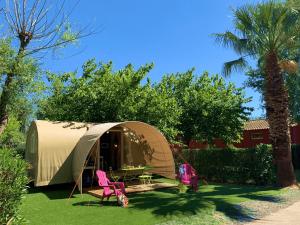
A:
[96,170,126,201]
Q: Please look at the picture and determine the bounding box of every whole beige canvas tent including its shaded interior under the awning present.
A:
[25,120,175,190]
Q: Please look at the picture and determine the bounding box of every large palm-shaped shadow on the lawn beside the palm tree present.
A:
[126,186,281,222]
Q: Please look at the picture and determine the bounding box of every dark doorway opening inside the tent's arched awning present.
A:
[99,130,123,171]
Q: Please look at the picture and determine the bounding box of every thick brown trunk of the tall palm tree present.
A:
[265,52,296,187]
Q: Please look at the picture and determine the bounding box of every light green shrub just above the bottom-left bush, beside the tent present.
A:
[0,116,25,156]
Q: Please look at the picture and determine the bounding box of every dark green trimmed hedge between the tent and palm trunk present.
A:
[184,145,275,185]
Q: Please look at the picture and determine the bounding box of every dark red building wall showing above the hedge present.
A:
[189,124,300,149]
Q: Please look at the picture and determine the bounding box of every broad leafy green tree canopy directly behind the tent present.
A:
[38,60,250,142]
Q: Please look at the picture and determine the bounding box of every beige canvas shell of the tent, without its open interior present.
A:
[26,120,175,186]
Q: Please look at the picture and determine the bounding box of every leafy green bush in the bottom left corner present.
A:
[0,148,28,224]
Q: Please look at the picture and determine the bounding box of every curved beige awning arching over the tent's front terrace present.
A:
[72,121,175,192]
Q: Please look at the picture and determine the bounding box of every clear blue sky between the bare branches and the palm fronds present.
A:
[44,0,262,117]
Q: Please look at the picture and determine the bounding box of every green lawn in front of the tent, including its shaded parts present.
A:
[21,180,283,225]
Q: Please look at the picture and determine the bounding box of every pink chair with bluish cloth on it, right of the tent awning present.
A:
[177,163,199,191]
